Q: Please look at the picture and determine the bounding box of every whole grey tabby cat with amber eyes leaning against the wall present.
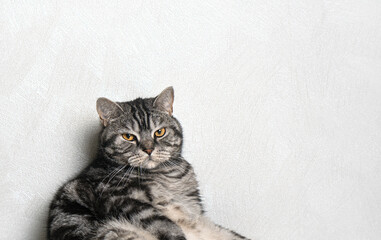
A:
[48,87,247,240]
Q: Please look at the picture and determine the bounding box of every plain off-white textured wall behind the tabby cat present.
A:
[0,0,381,240]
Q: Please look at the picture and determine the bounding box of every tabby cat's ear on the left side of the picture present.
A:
[97,98,123,127]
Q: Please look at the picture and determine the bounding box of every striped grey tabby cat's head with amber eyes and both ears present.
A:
[97,87,182,169]
